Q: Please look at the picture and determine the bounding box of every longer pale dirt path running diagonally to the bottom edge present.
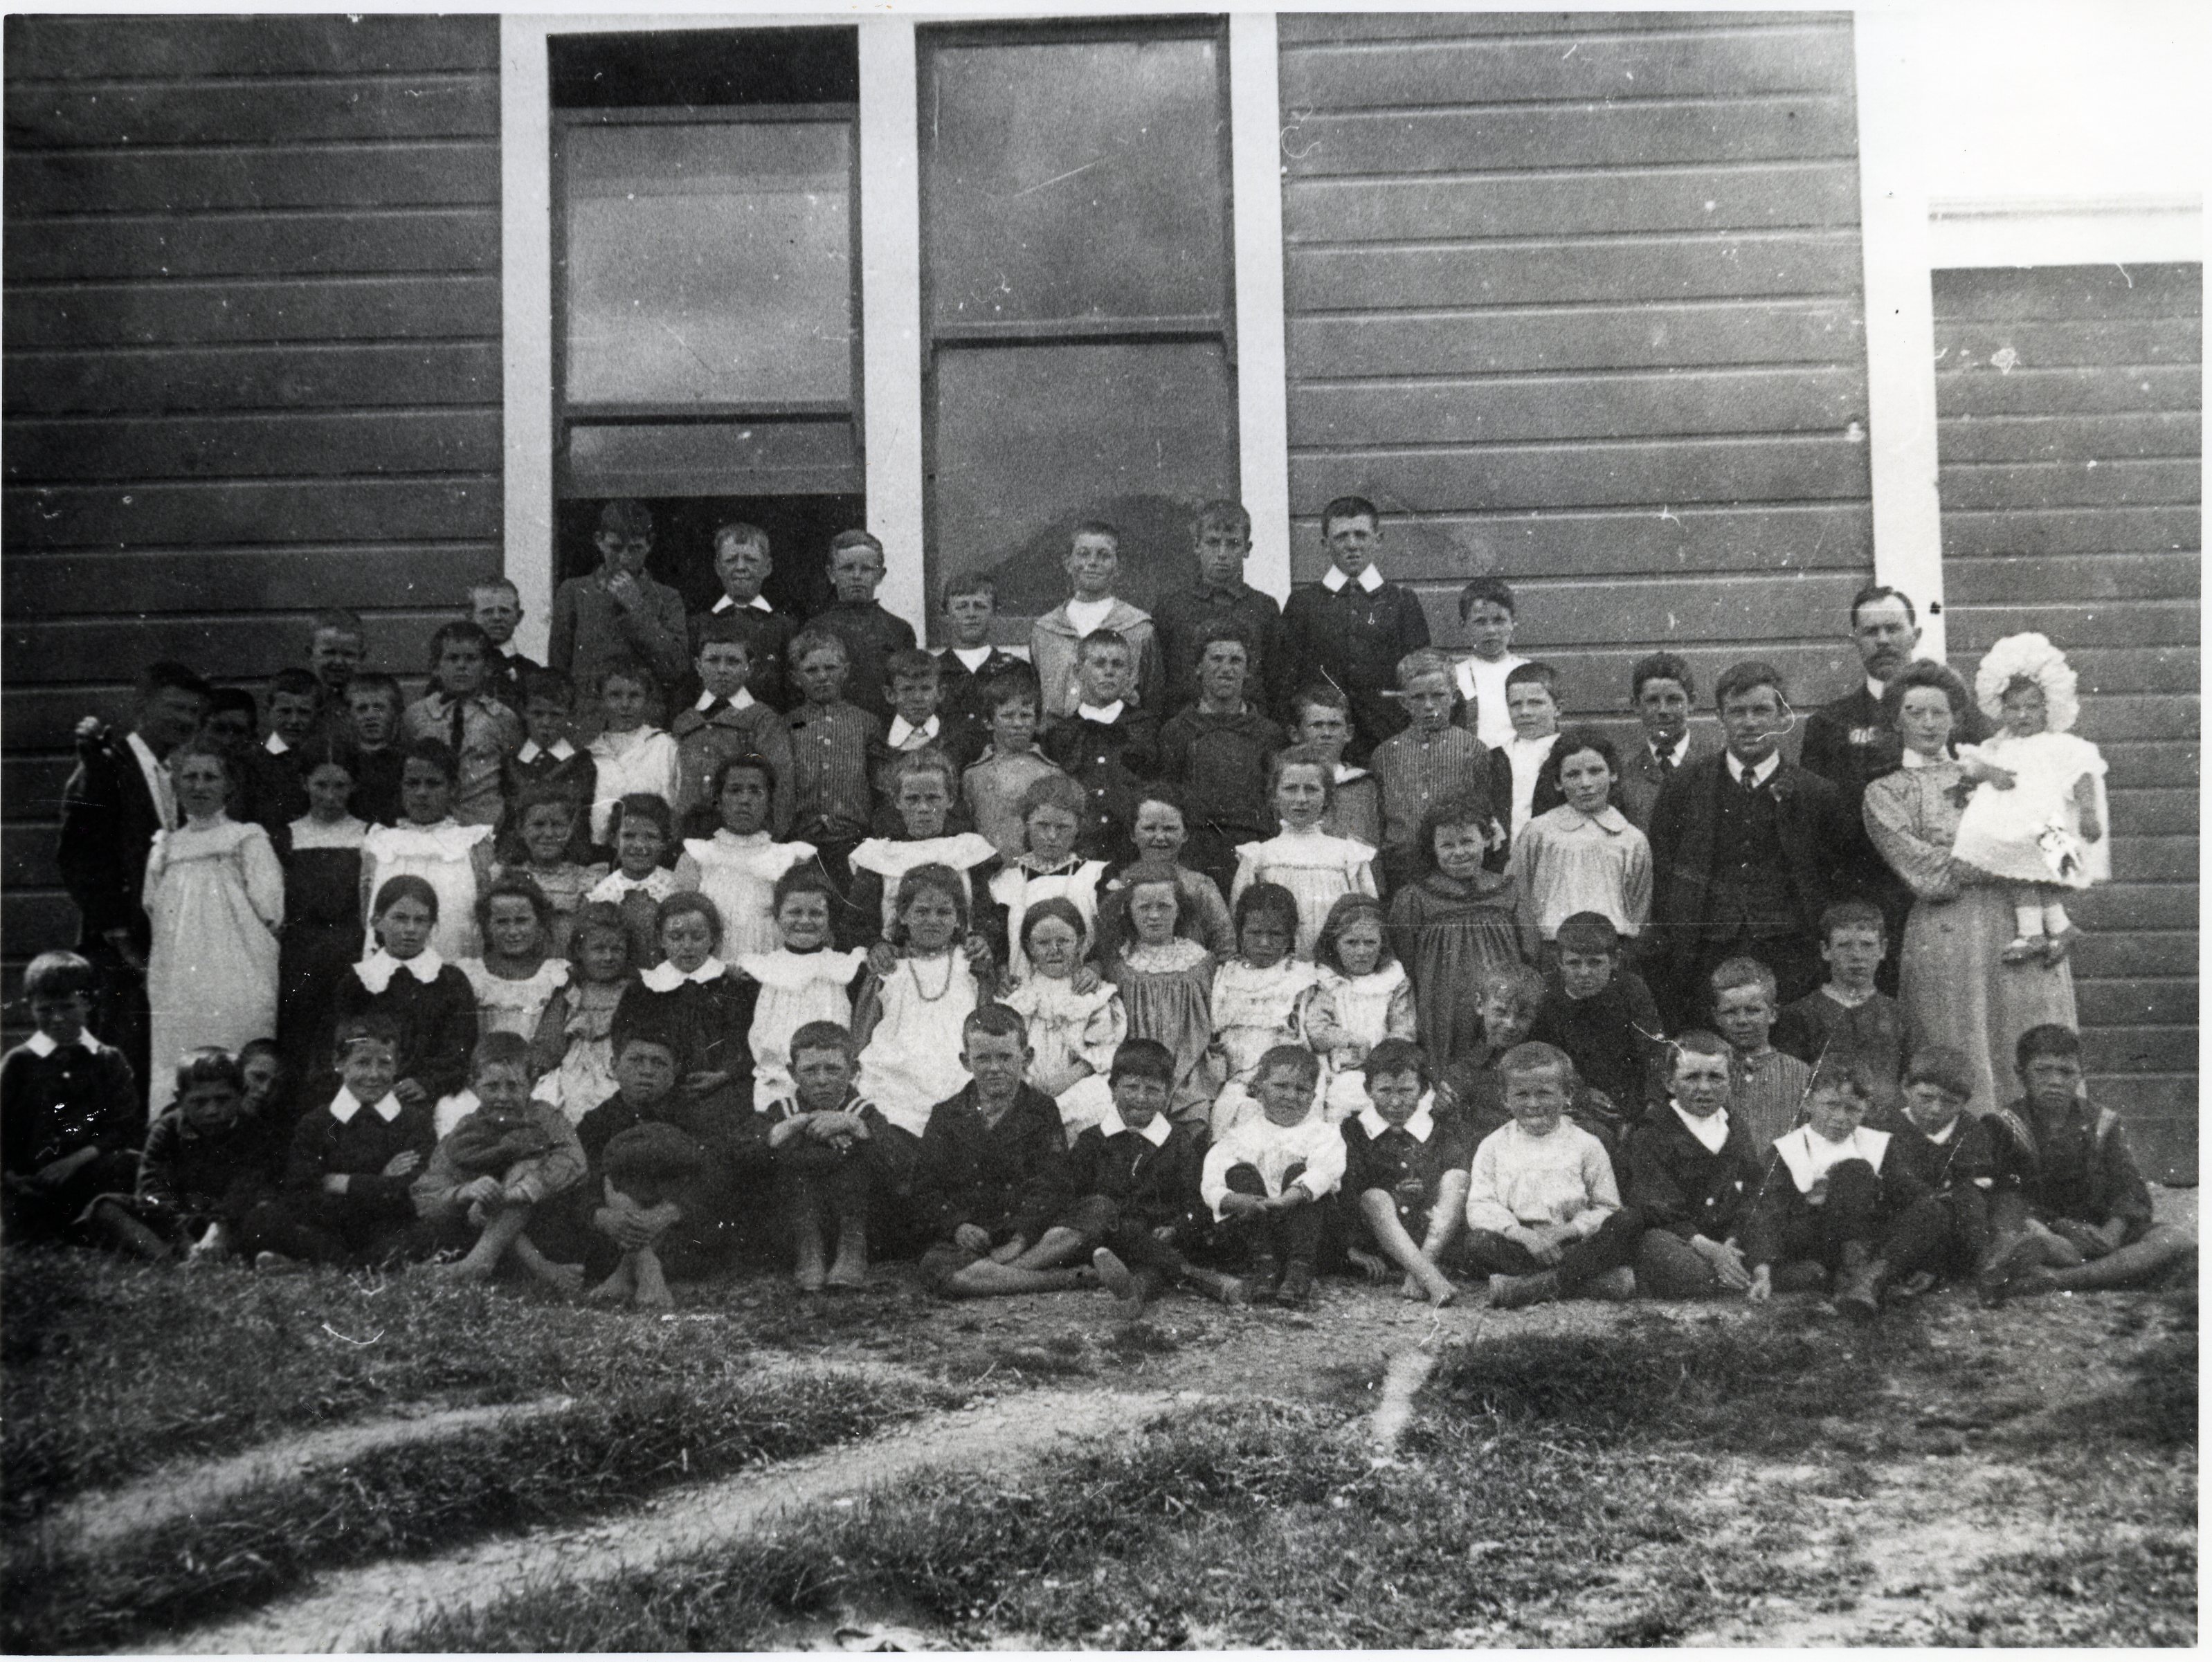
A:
[159,1390,1204,1653]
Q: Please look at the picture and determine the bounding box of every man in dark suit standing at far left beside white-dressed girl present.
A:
[55,661,208,1096]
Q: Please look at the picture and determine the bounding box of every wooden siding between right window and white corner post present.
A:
[1280,13,1871,714]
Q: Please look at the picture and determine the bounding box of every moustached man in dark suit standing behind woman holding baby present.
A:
[1798,583,1984,997]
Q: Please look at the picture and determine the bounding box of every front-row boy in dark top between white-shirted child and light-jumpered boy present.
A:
[1339,1039,1476,1306]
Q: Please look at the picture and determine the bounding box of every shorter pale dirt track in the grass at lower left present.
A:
[42,1397,575,1551]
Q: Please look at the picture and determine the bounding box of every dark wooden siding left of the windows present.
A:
[0,15,500,1025]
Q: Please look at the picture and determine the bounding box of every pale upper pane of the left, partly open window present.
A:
[562,122,854,405]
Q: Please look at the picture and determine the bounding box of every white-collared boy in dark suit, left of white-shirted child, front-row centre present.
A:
[1079,1039,1245,1317]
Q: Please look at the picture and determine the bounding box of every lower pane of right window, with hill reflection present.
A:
[934,343,1237,619]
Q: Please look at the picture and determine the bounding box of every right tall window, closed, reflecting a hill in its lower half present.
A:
[921,18,1237,639]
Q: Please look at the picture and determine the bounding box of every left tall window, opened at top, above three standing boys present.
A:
[549,29,862,603]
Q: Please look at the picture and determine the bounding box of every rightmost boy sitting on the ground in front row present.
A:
[1982,1023,2197,1302]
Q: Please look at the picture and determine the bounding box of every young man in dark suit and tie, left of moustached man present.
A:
[1648,661,1847,1032]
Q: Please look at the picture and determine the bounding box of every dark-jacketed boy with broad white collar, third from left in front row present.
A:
[239,1012,438,1271]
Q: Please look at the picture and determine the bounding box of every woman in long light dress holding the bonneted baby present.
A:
[1865,663,2077,1114]
